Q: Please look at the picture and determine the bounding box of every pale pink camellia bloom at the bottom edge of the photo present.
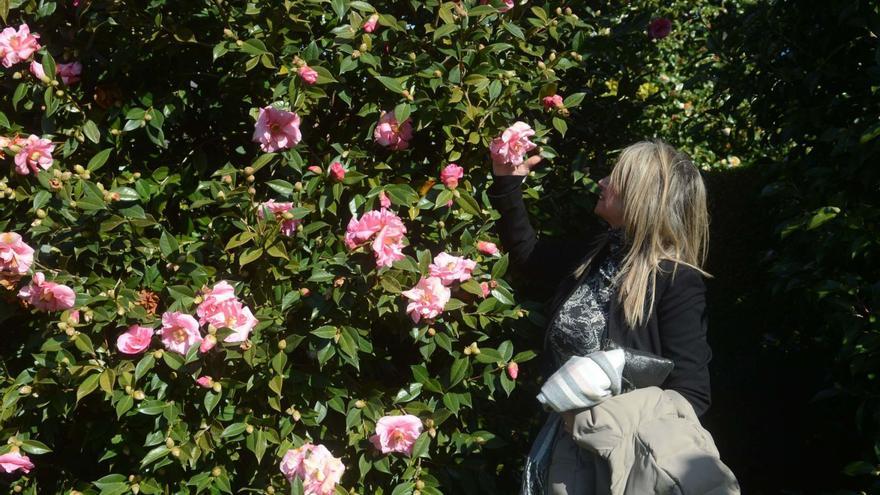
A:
[280,443,345,495]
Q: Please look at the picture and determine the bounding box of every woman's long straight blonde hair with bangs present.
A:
[592,140,709,328]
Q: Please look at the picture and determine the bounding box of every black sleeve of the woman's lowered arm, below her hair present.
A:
[657,266,712,416]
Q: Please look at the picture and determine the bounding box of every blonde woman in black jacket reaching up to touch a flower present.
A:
[488,141,712,495]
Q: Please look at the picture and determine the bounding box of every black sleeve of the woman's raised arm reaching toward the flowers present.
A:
[487,175,589,296]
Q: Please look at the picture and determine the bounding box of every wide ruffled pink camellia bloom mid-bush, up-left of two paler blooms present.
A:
[345,208,406,267]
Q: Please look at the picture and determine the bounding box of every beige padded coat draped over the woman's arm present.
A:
[572,387,740,495]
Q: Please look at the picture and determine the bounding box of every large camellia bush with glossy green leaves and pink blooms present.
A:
[0,0,620,494]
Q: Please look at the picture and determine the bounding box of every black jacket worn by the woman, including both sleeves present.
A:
[488,176,712,416]
